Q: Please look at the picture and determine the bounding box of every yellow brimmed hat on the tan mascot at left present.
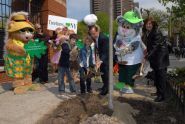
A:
[7,12,34,32]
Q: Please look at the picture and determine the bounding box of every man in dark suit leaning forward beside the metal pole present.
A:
[89,25,109,95]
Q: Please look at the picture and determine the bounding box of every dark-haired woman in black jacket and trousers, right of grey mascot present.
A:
[143,17,169,102]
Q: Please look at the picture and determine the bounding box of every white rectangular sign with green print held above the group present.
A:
[47,15,78,33]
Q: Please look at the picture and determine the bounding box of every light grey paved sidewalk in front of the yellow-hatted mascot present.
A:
[0,75,77,124]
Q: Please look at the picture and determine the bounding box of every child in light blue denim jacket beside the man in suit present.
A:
[79,36,94,94]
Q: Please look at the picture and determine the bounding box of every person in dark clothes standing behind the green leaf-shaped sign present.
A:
[32,24,48,84]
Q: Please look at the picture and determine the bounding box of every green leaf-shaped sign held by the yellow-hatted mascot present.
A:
[24,39,47,58]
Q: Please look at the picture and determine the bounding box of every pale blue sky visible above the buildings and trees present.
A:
[66,0,171,21]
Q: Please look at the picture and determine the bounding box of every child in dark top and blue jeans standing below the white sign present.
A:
[58,26,76,93]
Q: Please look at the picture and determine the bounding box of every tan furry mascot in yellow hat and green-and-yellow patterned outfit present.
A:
[4,12,41,93]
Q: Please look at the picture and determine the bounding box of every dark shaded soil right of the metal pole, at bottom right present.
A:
[117,97,185,124]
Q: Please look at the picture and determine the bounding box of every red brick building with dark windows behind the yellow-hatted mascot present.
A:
[0,0,67,66]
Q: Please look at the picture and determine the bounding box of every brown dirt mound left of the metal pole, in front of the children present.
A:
[38,94,112,124]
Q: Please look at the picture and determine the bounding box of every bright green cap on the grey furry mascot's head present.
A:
[123,11,143,24]
